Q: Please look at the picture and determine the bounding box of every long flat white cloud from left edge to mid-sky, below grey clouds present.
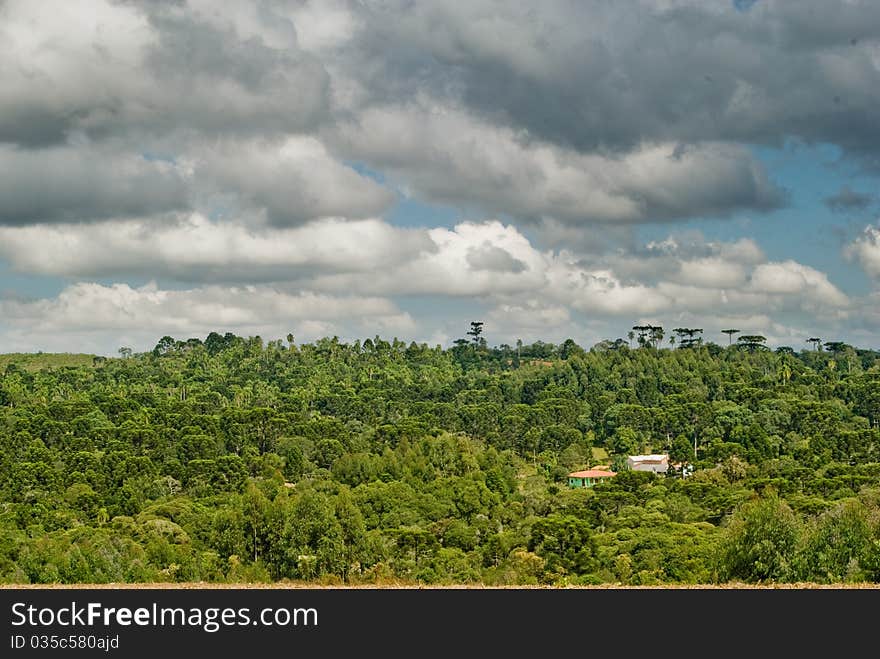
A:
[0,214,436,282]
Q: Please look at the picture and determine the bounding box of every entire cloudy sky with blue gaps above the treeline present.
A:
[0,0,880,355]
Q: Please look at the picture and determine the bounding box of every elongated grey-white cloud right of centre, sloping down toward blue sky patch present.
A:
[331,105,785,224]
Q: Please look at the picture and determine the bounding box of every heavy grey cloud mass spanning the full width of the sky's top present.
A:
[0,0,880,237]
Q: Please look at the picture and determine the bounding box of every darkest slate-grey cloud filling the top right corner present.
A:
[348,0,880,159]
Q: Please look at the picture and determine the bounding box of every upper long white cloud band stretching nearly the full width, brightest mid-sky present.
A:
[0,215,850,330]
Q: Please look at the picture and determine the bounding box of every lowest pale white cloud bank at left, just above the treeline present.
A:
[0,282,415,350]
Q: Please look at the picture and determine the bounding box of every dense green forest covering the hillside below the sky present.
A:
[0,330,880,585]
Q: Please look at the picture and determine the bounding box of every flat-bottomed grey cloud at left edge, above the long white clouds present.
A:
[0,146,190,226]
